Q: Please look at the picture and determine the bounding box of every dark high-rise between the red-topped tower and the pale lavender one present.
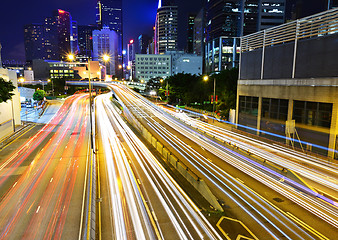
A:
[77,25,97,61]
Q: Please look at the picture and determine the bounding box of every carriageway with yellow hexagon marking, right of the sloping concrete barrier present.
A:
[113,86,338,239]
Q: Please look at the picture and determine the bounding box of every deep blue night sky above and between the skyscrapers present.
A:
[0,0,202,61]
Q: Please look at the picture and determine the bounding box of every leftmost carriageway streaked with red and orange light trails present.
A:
[0,95,89,239]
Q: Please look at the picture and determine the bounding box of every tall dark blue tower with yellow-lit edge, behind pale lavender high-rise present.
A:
[96,0,123,76]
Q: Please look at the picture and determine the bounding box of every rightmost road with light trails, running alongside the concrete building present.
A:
[169,108,338,203]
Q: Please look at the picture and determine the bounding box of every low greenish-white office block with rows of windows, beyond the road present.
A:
[135,54,171,81]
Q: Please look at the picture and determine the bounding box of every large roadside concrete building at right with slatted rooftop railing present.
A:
[236,9,338,157]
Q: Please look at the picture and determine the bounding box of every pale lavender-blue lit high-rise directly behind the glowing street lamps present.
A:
[93,27,119,76]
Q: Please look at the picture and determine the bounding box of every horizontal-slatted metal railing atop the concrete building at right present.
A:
[241,8,338,52]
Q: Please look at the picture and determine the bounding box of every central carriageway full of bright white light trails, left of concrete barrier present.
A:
[95,94,222,239]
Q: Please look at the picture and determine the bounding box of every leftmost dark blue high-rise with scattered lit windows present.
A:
[24,24,46,62]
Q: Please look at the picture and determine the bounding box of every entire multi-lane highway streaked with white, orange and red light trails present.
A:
[0,85,338,240]
